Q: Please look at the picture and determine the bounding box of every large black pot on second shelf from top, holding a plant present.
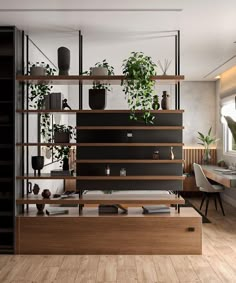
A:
[89,89,106,110]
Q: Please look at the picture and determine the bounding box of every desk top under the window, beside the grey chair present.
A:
[202,165,236,188]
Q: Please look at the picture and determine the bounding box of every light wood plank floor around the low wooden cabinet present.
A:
[0,200,236,283]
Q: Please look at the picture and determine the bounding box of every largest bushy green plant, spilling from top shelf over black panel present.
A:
[122,52,158,124]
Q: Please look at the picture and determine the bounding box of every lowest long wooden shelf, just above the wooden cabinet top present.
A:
[16,194,185,205]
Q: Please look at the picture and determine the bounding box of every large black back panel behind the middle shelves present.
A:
[77,111,183,191]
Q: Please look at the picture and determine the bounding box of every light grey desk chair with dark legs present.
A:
[193,163,225,216]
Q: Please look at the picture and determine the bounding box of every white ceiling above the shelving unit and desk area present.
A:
[0,0,236,80]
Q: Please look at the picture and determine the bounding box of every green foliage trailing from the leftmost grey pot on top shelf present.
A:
[29,62,56,109]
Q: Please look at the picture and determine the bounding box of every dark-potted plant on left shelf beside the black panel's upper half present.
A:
[53,124,75,143]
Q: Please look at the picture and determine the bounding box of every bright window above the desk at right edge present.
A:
[221,96,236,155]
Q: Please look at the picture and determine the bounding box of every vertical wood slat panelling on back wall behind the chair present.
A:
[183,148,217,173]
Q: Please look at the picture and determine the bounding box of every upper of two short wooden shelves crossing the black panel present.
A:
[75,126,184,131]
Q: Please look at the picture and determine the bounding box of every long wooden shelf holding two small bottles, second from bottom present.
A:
[16,174,185,181]
